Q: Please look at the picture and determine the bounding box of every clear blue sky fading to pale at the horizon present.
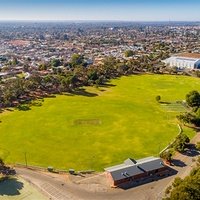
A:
[0,0,200,21]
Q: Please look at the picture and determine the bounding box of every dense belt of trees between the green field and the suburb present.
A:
[0,54,168,108]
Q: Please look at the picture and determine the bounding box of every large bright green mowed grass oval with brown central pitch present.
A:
[0,75,200,170]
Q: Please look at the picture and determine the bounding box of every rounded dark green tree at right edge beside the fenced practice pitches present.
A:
[186,90,200,107]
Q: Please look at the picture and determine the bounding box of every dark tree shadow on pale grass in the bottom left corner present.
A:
[0,178,24,196]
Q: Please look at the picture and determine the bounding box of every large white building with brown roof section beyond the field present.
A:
[163,53,200,70]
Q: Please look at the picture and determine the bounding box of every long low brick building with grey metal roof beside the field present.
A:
[105,157,168,186]
